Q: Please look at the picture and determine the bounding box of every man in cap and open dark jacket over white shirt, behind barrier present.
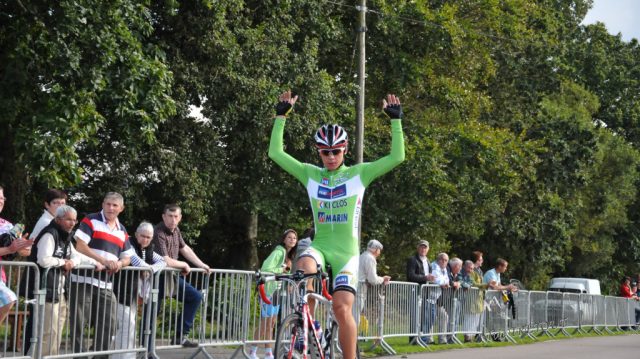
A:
[407,240,436,344]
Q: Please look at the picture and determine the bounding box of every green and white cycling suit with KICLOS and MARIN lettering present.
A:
[269,117,404,289]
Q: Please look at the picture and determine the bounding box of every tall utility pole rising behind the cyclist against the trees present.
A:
[356,0,367,163]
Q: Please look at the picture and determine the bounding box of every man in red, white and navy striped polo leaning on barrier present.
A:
[69,192,132,359]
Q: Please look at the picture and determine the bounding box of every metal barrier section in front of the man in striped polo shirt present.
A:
[48,266,153,359]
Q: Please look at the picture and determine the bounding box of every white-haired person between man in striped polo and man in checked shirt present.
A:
[111,222,167,359]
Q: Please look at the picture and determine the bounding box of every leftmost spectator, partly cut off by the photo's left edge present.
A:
[0,187,33,323]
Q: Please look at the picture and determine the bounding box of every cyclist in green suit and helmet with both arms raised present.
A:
[269,91,404,359]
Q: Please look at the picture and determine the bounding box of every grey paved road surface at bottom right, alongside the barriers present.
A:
[386,334,640,359]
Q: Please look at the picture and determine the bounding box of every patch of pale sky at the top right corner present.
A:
[582,0,640,41]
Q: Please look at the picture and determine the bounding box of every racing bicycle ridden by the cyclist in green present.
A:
[256,267,342,359]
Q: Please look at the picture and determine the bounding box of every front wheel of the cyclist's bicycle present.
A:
[274,313,320,359]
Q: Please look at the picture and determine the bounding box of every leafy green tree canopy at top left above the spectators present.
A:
[0,0,175,218]
